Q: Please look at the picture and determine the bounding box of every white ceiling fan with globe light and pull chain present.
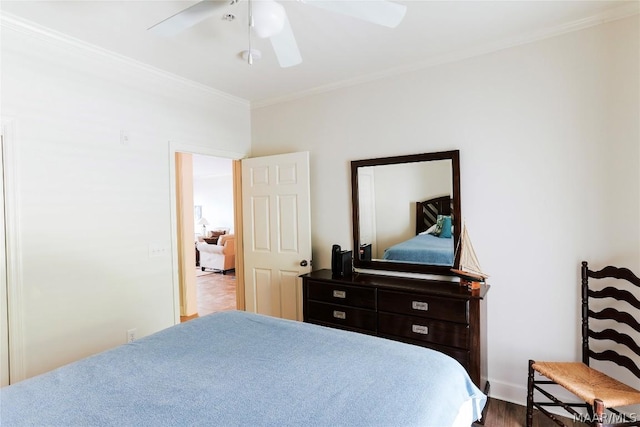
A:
[148,0,407,68]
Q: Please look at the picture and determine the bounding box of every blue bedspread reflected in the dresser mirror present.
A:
[383,234,453,266]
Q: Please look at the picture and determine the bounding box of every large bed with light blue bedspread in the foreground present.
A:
[0,311,486,427]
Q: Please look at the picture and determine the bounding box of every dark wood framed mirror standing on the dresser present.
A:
[351,150,461,275]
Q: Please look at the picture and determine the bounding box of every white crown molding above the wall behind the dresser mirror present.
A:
[251,0,640,110]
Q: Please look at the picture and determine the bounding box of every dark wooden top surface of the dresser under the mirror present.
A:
[300,269,490,299]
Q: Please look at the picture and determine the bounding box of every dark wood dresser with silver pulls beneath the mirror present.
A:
[301,270,489,392]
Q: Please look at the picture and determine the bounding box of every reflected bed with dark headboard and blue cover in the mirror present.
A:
[382,195,455,266]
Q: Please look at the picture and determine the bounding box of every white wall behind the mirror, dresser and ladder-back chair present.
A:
[251,15,640,403]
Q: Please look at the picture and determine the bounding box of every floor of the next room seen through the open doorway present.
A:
[180,268,237,322]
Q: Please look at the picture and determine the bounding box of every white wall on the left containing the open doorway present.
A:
[1,17,250,380]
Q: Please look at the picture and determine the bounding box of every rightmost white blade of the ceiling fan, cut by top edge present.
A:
[301,0,407,28]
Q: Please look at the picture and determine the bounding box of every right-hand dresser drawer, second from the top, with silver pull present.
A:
[378,313,469,349]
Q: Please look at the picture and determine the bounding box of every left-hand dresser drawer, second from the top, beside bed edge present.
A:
[305,301,377,332]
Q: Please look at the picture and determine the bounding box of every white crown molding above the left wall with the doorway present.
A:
[0,11,250,107]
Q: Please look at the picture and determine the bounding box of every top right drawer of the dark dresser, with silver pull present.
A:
[378,290,469,323]
